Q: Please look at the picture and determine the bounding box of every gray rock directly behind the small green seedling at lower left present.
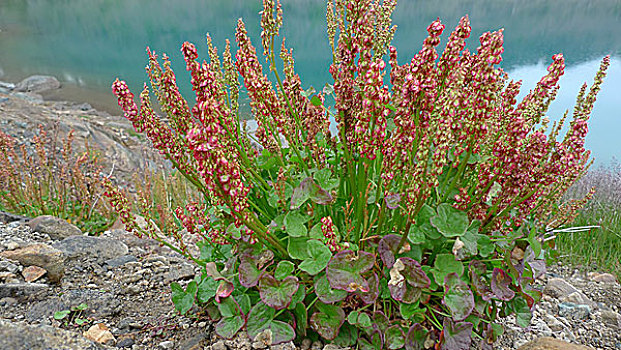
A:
[26,289,122,322]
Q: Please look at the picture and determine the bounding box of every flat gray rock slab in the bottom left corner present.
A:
[0,319,112,350]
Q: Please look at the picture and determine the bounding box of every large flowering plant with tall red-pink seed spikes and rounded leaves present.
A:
[108,0,609,349]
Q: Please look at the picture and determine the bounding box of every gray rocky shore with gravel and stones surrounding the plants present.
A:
[0,75,621,350]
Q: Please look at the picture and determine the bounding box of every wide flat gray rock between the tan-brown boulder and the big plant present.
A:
[53,236,128,262]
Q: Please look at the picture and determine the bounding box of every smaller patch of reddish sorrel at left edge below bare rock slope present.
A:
[0,124,116,234]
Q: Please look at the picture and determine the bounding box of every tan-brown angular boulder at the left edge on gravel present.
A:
[0,243,65,283]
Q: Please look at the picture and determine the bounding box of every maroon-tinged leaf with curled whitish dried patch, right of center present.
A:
[388,258,431,304]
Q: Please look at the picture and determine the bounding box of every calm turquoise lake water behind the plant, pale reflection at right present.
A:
[0,0,621,164]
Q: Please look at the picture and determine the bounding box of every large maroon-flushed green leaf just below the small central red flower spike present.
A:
[326,250,375,292]
